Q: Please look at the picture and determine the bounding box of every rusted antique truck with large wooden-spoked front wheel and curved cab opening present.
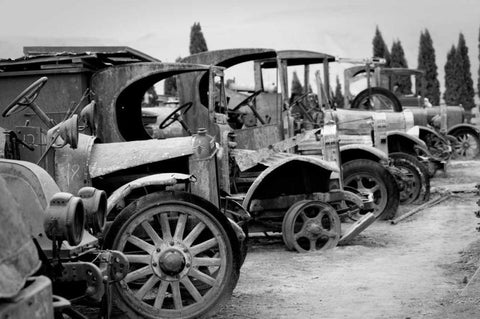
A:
[0,48,244,318]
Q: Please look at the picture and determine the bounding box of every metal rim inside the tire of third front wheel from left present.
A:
[344,172,388,217]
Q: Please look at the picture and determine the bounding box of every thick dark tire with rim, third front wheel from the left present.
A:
[342,159,400,220]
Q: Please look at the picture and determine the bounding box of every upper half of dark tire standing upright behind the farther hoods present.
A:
[350,87,403,112]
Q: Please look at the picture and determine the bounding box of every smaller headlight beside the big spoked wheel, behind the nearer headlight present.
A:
[78,187,107,234]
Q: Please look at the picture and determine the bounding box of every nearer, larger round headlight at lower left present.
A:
[44,193,85,246]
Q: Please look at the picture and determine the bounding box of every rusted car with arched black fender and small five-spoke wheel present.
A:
[172,49,374,251]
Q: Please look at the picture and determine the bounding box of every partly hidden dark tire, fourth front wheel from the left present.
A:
[388,153,430,205]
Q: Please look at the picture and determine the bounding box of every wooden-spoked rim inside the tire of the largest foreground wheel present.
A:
[114,203,231,318]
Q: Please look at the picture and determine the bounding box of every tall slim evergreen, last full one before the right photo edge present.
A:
[456,33,475,111]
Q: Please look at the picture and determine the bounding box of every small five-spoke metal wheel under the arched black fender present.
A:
[282,200,341,253]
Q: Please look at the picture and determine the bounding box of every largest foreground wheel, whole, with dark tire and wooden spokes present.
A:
[104,192,240,319]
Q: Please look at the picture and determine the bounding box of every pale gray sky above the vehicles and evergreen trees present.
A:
[0,0,480,94]
